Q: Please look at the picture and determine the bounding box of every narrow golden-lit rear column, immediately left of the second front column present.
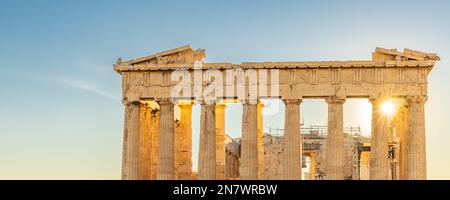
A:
[150,109,160,180]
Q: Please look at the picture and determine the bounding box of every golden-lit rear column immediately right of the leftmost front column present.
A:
[139,103,152,180]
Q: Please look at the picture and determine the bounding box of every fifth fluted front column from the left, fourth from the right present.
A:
[282,99,302,180]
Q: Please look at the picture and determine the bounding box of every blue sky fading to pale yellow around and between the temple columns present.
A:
[0,0,450,179]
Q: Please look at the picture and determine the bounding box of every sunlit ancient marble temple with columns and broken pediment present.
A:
[113,45,439,180]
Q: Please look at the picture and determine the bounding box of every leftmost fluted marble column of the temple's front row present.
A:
[122,101,141,180]
